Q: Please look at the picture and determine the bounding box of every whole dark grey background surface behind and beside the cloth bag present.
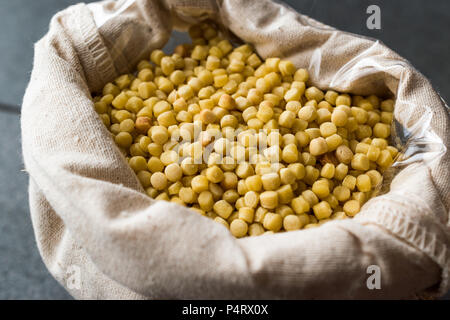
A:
[0,0,450,299]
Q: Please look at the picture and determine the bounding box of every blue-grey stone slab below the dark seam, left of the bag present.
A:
[0,112,70,299]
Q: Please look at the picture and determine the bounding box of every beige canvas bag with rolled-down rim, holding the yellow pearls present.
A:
[22,0,450,299]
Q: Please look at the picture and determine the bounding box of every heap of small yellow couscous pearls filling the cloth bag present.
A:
[94,23,398,237]
